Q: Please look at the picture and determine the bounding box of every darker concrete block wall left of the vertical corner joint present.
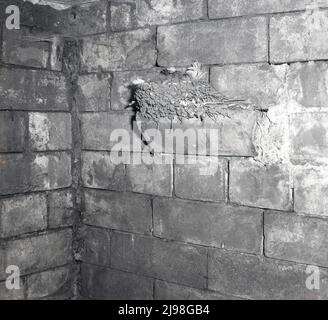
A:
[0,1,79,299]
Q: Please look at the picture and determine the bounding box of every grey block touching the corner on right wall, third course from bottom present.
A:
[83,190,152,234]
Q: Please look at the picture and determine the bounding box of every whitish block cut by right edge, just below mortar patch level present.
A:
[294,166,328,216]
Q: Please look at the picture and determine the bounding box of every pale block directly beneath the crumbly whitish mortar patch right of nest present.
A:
[230,159,291,211]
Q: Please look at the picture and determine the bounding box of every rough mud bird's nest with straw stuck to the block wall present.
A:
[133,62,259,122]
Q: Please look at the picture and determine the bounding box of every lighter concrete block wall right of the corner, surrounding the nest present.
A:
[76,0,328,299]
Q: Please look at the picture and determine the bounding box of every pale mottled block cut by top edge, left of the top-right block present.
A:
[111,0,206,30]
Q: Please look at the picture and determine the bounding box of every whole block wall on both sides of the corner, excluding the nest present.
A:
[0,0,328,299]
